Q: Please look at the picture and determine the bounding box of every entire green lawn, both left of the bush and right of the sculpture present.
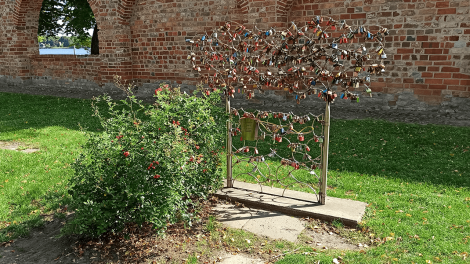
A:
[0,93,470,263]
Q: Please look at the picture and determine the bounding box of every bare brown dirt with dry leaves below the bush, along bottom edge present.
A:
[0,198,368,264]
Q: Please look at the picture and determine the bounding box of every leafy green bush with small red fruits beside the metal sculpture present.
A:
[64,81,227,236]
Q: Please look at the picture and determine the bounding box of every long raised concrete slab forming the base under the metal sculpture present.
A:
[215,181,367,227]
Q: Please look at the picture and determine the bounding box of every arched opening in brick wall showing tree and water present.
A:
[38,0,99,55]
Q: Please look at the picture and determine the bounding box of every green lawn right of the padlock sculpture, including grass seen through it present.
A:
[228,113,470,263]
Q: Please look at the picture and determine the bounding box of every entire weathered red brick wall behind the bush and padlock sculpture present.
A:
[0,0,470,111]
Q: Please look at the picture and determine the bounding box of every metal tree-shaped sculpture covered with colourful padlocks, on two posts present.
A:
[186,16,388,204]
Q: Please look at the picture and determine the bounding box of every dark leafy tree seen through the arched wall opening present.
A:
[38,0,99,54]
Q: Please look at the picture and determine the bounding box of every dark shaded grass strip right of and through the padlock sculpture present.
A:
[233,116,470,187]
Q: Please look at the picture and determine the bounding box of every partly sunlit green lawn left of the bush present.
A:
[0,93,101,242]
